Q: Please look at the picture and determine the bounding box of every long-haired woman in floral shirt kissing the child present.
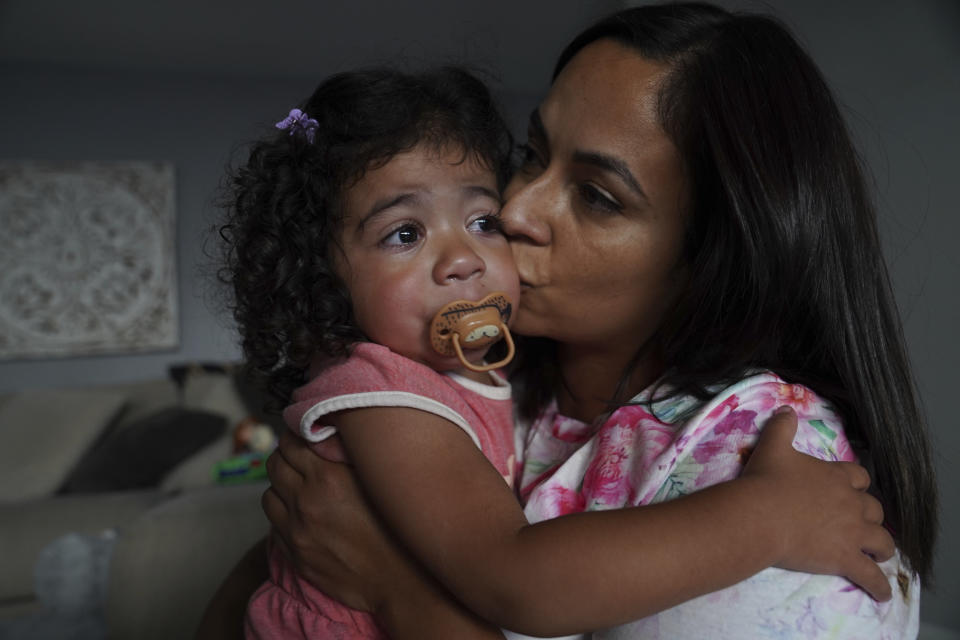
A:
[204,5,936,637]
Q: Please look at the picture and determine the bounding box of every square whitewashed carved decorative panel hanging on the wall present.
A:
[0,161,178,359]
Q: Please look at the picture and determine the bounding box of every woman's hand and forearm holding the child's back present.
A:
[261,432,503,640]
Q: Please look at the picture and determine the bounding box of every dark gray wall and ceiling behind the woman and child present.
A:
[0,0,960,638]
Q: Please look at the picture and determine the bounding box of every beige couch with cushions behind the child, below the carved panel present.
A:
[0,369,278,640]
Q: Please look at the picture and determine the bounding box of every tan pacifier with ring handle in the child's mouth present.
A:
[430,293,514,371]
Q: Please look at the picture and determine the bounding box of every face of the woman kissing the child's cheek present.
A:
[502,40,686,353]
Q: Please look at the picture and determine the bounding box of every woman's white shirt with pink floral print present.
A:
[511,373,920,640]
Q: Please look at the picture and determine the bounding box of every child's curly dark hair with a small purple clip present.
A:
[218,67,513,409]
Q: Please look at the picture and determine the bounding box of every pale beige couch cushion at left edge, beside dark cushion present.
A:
[0,390,126,502]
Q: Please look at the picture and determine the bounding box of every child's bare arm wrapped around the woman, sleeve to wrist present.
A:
[333,408,887,635]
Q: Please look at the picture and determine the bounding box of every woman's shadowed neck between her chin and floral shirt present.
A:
[557,344,663,422]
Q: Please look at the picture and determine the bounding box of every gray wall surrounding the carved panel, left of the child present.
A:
[0,67,292,392]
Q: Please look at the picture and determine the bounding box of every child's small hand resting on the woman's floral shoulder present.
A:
[743,408,894,601]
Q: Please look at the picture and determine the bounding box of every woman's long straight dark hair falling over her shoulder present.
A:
[519,3,937,584]
